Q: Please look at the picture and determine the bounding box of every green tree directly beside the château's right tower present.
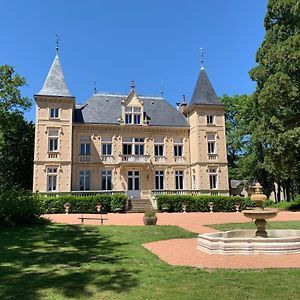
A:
[221,95,273,195]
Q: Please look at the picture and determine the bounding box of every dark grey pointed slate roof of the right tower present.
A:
[188,68,224,109]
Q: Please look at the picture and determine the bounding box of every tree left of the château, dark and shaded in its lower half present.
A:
[0,65,34,189]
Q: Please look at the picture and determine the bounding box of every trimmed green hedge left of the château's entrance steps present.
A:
[41,194,127,214]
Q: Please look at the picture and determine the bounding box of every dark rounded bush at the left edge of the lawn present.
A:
[0,190,43,225]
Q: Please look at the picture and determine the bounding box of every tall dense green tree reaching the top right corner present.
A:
[250,0,300,202]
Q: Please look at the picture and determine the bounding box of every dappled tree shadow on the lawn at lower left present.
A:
[0,225,138,300]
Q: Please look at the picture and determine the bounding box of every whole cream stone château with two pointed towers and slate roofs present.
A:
[33,55,229,206]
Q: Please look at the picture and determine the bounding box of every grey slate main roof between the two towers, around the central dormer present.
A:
[75,94,189,127]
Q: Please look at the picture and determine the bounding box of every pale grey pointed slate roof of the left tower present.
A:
[38,55,71,97]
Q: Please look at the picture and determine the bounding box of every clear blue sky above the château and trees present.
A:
[0,0,267,121]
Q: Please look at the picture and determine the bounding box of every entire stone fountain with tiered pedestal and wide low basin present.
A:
[197,183,300,255]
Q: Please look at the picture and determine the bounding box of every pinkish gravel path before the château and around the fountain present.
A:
[45,212,300,269]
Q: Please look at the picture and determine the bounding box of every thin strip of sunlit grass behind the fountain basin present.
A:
[206,221,300,231]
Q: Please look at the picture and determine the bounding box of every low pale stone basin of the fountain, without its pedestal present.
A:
[197,229,300,255]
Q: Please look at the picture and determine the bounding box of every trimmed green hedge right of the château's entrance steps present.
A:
[156,195,255,212]
